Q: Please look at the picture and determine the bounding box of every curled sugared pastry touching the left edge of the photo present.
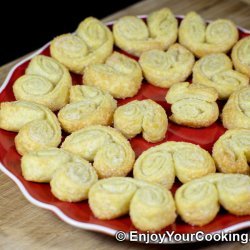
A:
[0,101,61,155]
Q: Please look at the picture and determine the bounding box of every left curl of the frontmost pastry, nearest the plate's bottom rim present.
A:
[89,177,138,220]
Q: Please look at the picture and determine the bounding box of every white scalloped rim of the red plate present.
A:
[0,15,250,244]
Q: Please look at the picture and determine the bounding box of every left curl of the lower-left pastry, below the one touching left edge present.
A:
[21,148,88,183]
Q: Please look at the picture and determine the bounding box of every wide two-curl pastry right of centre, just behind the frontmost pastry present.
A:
[133,142,215,189]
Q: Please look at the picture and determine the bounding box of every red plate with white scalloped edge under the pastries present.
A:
[0,16,250,242]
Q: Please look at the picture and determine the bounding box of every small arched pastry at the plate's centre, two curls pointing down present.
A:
[114,99,168,142]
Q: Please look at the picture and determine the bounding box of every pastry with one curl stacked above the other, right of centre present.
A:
[166,82,219,128]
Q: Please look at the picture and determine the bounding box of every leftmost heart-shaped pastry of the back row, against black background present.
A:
[50,17,113,74]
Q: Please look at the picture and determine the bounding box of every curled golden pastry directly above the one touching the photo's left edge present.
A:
[13,55,72,111]
